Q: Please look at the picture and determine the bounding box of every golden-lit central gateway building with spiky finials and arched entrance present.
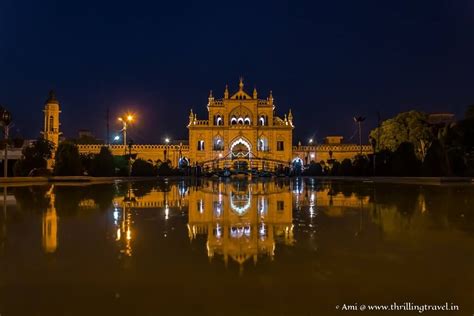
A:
[188,79,294,168]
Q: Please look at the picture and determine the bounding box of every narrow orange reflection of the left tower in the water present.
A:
[42,185,58,253]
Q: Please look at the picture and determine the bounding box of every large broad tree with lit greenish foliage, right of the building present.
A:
[370,111,435,160]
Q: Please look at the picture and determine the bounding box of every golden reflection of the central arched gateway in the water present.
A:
[188,181,293,264]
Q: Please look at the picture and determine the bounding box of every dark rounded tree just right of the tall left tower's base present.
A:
[54,142,82,176]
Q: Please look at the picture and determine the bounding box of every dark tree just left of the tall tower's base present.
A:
[13,138,54,177]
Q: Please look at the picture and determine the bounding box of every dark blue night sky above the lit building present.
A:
[0,0,474,142]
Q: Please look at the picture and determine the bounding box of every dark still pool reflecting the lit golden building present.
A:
[0,178,474,316]
